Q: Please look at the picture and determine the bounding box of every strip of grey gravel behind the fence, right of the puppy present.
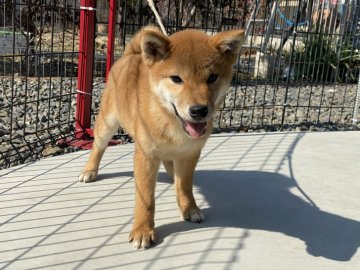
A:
[216,84,360,131]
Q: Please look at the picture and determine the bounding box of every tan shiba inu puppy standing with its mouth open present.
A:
[79,26,243,248]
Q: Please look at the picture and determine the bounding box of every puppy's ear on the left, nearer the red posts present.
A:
[140,27,170,65]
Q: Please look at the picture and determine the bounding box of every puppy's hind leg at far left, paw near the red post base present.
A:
[79,109,119,182]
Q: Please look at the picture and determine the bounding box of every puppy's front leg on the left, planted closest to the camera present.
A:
[129,146,160,248]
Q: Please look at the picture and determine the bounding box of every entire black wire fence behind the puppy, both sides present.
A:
[0,0,360,168]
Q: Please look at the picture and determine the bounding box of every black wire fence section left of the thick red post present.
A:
[0,0,78,168]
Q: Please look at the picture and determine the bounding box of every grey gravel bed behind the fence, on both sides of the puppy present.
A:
[0,76,360,169]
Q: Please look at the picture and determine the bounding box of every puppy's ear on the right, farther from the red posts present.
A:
[211,30,244,61]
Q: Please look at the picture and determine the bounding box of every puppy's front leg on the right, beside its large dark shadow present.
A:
[174,151,204,223]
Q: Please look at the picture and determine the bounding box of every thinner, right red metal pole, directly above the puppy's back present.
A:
[106,0,116,81]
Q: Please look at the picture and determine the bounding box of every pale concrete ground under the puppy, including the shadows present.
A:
[0,132,360,270]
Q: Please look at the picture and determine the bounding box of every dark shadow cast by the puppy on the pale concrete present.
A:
[156,170,360,261]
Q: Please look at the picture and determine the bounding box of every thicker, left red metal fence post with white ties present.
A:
[75,0,96,140]
